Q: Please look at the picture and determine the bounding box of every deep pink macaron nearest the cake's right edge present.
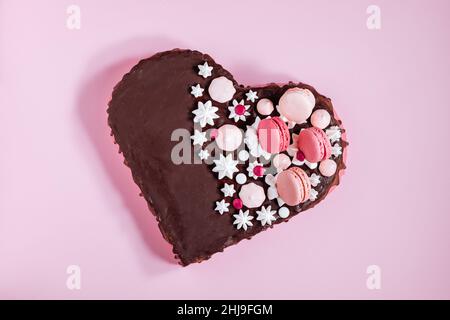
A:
[297,127,331,163]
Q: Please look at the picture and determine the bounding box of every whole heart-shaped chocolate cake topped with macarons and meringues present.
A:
[108,49,348,265]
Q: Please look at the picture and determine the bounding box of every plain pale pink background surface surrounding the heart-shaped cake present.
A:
[0,0,450,299]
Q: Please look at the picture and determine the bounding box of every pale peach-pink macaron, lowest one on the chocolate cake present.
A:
[276,167,311,206]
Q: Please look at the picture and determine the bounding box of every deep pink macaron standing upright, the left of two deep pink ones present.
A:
[258,117,290,153]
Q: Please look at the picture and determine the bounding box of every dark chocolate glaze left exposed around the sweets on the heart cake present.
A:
[108,49,347,265]
